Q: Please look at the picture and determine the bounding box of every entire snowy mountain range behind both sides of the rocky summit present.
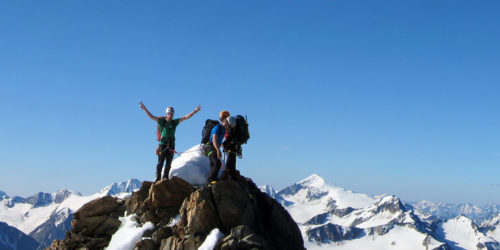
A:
[0,174,500,249]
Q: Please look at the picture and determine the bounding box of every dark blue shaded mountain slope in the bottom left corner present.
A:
[0,222,40,250]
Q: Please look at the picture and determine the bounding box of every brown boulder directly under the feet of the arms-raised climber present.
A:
[145,176,194,208]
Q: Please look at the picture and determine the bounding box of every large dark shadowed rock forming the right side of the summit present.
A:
[212,178,304,249]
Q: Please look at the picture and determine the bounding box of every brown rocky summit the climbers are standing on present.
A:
[48,176,305,250]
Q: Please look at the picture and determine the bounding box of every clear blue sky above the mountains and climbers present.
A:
[0,1,500,204]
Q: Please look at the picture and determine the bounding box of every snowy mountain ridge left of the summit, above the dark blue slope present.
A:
[0,179,141,247]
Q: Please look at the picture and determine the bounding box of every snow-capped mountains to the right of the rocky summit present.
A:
[268,175,500,249]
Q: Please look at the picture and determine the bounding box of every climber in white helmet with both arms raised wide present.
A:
[139,102,201,181]
